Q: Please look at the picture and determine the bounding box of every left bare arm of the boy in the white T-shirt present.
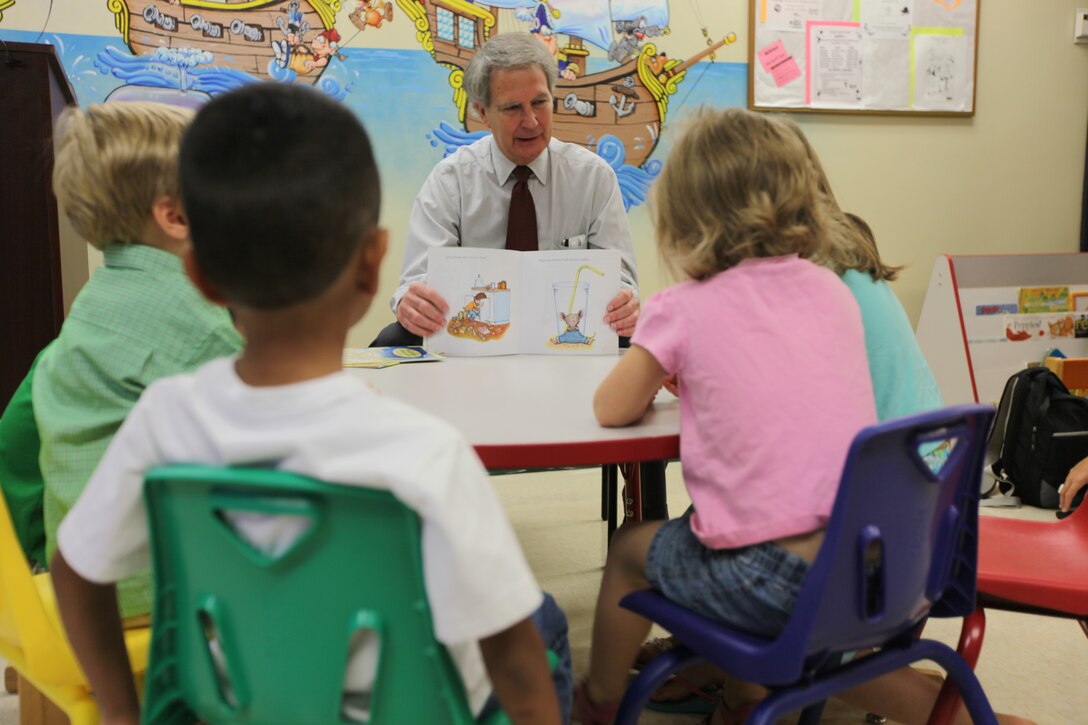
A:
[50,552,139,725]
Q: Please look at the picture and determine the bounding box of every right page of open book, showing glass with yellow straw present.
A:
[521,249,620,355]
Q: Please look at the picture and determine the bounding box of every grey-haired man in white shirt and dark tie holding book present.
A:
[371,33,640,346]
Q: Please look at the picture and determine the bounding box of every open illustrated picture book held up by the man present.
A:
[426,247,620,356]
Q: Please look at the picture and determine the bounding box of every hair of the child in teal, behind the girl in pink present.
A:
[775,115,903,282]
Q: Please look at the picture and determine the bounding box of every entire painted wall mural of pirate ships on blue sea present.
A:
[0,0,746,209]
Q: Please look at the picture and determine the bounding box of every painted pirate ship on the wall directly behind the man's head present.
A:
[397,0,737,170]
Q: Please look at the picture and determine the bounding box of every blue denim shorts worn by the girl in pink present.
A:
[646,508,808,637]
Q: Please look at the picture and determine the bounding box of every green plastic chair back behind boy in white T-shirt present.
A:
[143,466,508,725]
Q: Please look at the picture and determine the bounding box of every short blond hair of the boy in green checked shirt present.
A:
[53,101,193,249]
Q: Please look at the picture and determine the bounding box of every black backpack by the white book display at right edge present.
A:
[984,367,1088,508]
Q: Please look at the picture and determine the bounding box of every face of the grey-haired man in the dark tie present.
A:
[477,65,552,165]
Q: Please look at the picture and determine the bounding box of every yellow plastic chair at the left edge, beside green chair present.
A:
[0,478,151,725]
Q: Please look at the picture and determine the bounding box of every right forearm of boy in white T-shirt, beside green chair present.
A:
[480,618,559,724]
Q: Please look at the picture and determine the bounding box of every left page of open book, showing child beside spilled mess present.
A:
[428,248,520,355]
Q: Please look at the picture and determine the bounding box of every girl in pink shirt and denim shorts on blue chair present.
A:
[576,109,876,724]
